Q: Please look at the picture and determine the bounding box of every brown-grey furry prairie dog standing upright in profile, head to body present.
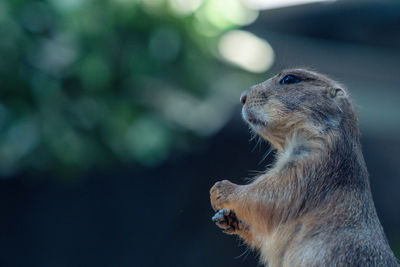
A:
[210,69,399,267]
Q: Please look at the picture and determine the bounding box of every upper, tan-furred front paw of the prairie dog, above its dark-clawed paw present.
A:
[210,180,238,211]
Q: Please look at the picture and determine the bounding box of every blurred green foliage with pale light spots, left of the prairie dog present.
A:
[0,0,256,176]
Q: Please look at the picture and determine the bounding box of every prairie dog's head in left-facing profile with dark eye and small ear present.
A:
[240,69,357,149]
